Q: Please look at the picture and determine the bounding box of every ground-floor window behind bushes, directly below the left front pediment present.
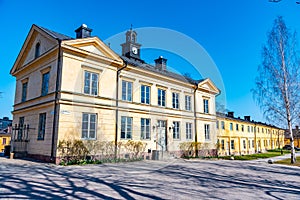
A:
[81,113,97,139]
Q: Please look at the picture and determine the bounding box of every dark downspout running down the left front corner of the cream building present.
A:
[50,38,61,161]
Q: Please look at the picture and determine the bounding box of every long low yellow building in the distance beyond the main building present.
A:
[216,112,284,155]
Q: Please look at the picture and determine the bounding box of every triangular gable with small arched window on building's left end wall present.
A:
[11,25,58,74]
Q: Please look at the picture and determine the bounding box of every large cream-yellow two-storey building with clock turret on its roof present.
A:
[11,25,219,162]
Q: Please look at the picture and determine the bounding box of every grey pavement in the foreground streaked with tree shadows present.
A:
[0,155,300,200]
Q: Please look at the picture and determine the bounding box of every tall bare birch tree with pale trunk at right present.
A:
[252,17,300,163]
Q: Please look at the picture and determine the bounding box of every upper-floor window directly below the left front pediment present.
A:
[84,71,98,95]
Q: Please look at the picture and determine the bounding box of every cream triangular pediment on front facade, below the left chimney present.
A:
[63,37,122,62]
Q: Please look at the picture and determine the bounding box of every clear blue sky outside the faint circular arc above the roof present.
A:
[0,0,300,121]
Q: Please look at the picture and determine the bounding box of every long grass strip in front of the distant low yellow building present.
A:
[219,149,290,160]
